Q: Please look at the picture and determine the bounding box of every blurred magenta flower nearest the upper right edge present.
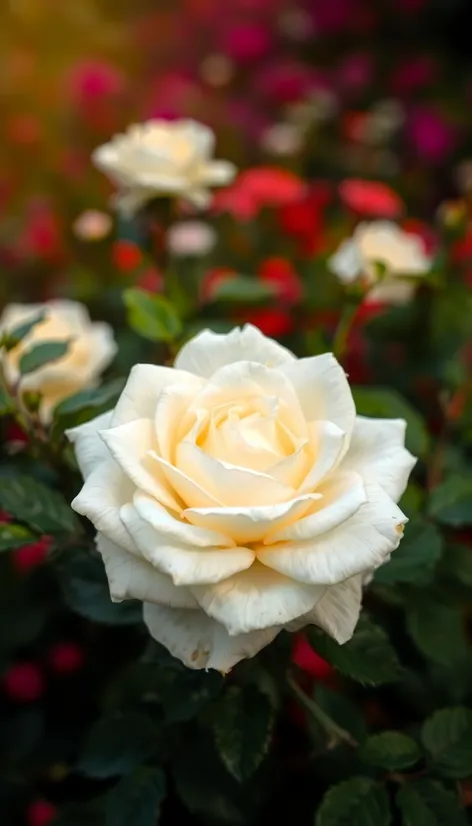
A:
[407,107,457,163]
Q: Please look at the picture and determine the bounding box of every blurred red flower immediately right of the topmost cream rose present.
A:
[213,166,306,221]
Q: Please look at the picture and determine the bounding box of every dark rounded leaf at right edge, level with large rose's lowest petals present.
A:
[406,595,469,665]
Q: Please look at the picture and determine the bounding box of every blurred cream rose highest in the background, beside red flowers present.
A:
[92,120,236,214]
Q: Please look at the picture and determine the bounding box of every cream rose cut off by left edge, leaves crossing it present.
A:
[0,299,117,423]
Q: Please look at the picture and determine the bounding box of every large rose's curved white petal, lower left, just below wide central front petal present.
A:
[120,505,256,586]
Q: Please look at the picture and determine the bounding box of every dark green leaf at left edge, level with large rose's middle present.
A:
[0,476,79,534]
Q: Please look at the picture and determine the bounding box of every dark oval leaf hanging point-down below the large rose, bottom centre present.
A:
[213,685,273,781]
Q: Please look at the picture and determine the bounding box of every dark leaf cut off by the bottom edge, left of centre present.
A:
[105,766,166,826]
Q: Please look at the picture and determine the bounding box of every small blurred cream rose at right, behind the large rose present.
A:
[329,221,431,304]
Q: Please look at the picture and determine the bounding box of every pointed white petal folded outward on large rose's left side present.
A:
[100,419,181,511]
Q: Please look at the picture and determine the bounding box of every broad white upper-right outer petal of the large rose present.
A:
[280,353,356,436]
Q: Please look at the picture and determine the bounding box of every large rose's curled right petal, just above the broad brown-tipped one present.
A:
[268,472,367,540]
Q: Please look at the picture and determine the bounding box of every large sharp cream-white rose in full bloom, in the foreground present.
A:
[68,326,415,672]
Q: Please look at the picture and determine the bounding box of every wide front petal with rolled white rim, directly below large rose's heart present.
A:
[183,493,321,543]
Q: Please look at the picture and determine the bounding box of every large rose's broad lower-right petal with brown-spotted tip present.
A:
[256,484,408,584]
